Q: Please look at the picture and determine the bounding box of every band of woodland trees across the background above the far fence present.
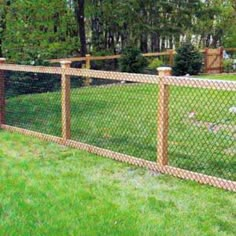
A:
[0,0,236,64]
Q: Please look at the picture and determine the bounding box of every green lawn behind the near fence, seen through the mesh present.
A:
[7,75,236,180]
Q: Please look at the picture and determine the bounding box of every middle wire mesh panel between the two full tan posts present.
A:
[71,78,158,161]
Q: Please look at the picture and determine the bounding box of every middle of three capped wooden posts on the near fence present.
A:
[61,61,71,141]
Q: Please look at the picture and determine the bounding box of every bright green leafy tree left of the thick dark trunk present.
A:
[3,0,79,64]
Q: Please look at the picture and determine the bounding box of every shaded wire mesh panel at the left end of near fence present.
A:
[4,71,61,136]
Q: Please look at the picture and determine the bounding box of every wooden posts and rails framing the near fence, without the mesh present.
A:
[0,60,236,192]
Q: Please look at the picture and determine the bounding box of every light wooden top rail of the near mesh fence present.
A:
[0,64,236,91]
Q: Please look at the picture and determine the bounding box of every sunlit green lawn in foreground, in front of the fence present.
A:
[0,131,236,236]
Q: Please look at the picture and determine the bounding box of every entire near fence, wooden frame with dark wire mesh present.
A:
[0,62,236,191]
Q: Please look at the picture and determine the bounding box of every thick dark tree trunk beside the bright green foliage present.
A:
[75,0,87,57]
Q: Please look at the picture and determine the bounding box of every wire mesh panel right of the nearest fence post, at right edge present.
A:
[169,87,236,180]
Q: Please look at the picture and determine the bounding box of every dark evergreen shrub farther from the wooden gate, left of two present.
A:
[119,47,148,73]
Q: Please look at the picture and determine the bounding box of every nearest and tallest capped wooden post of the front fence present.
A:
[157,67,172,166]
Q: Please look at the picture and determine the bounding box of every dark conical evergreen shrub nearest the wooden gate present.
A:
[173,42,202,76]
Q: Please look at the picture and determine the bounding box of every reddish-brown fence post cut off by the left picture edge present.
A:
[0,58,6,126]
